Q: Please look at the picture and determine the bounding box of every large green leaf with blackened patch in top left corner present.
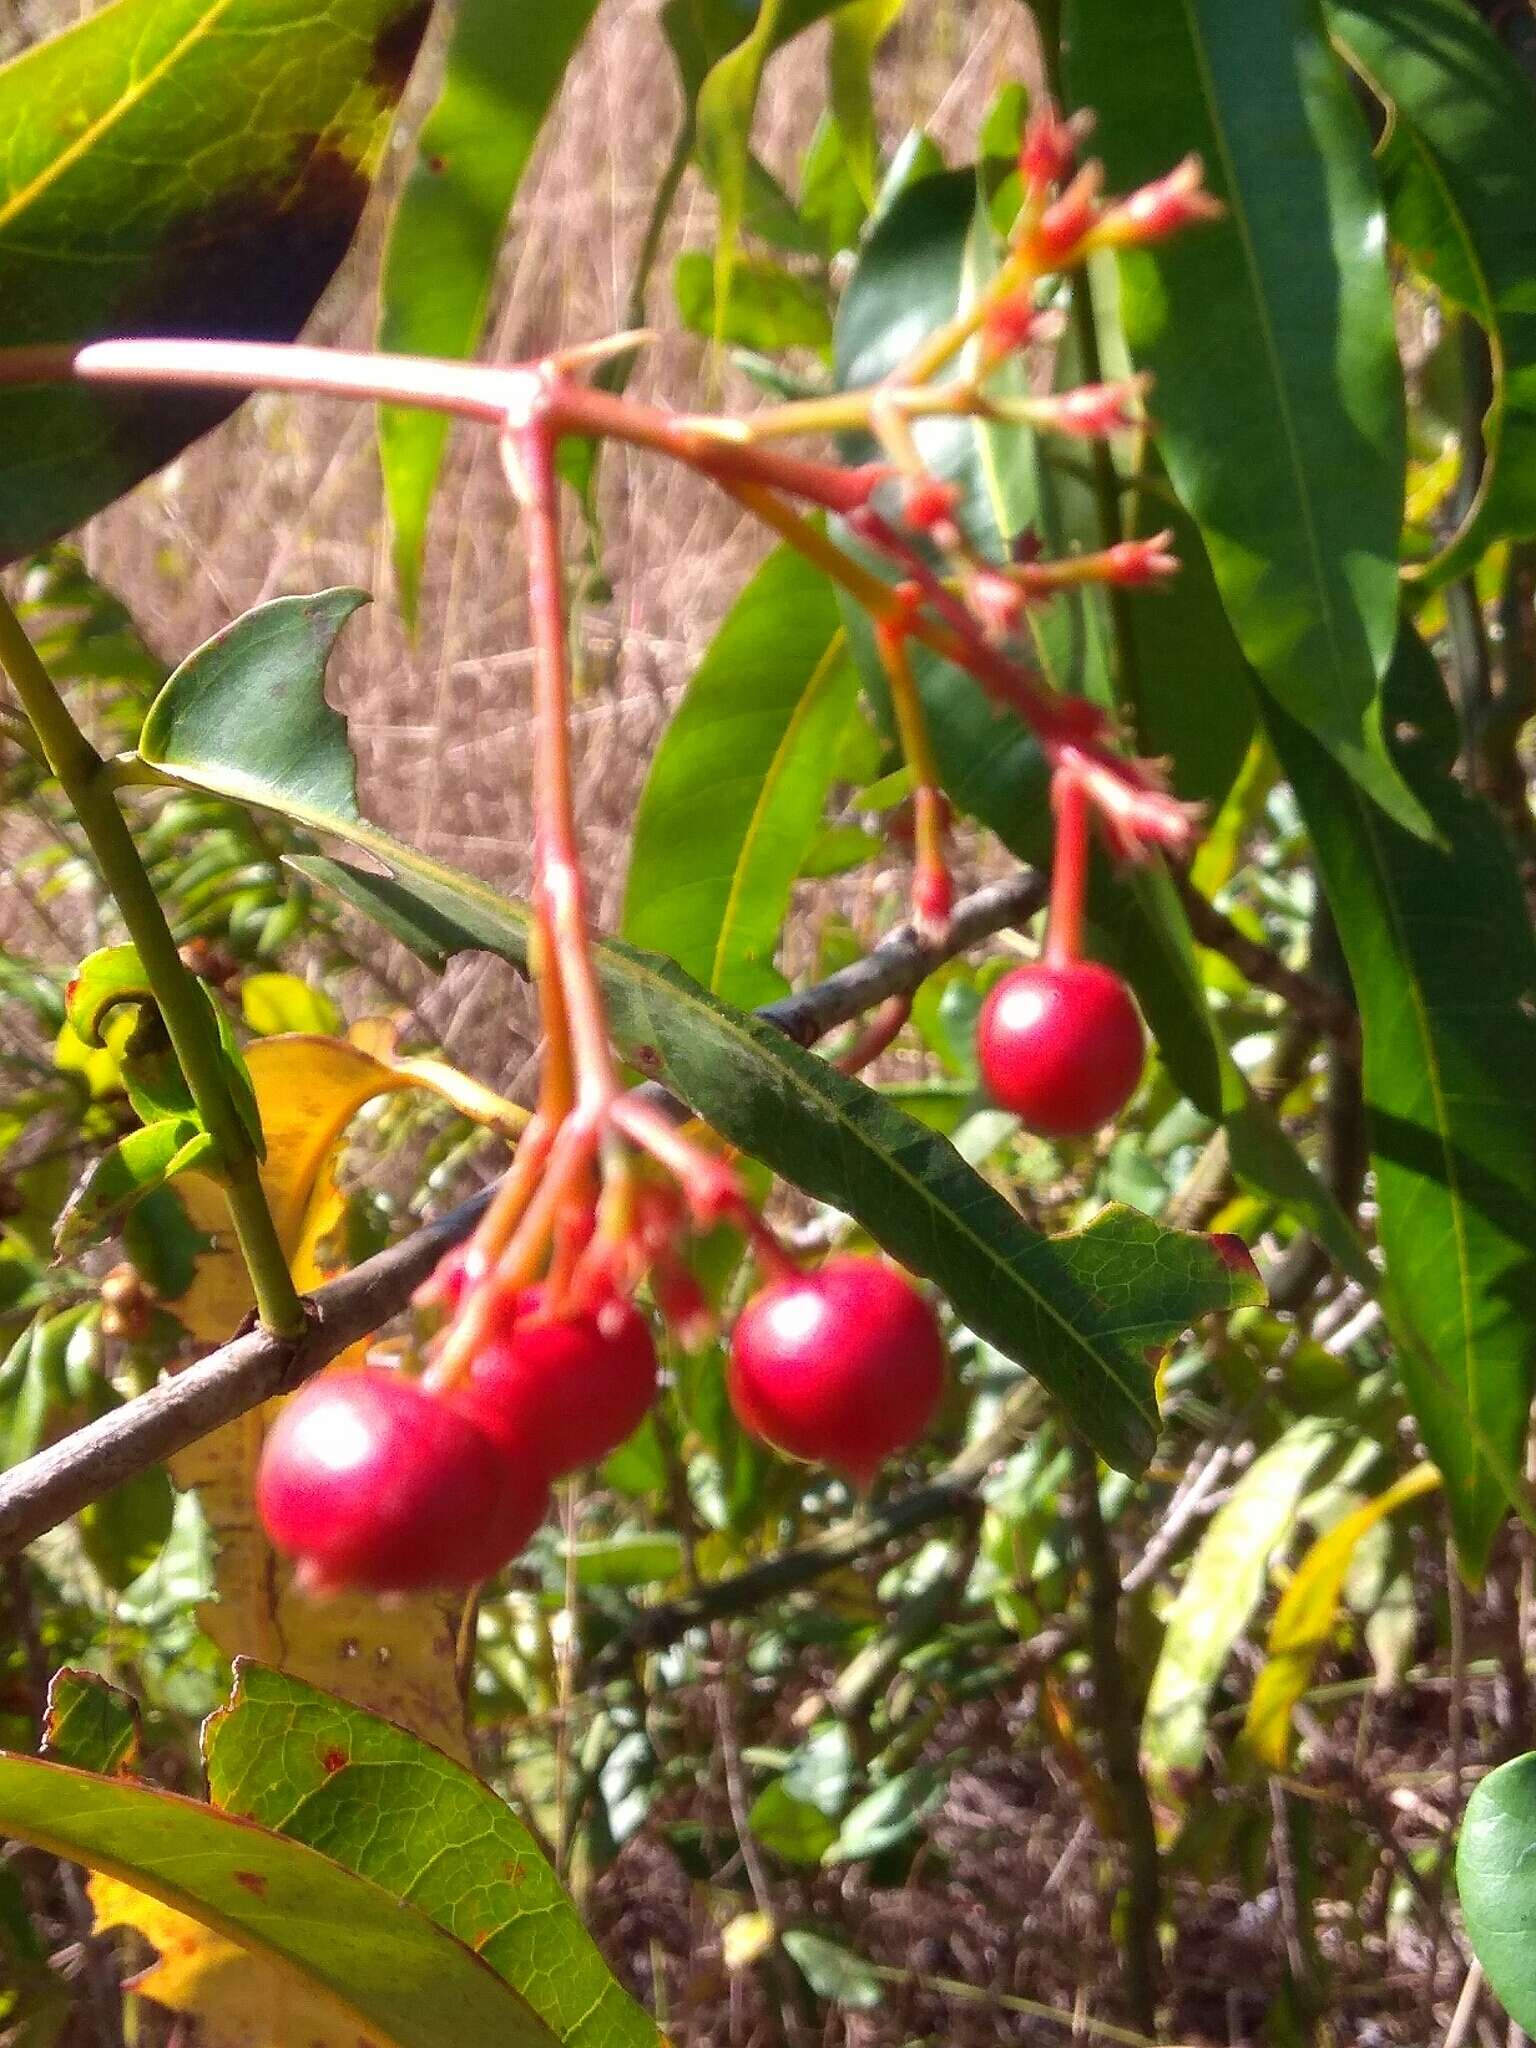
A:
[0,0,430,559]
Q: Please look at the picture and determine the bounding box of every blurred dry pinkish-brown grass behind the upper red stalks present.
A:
[12,0,1028,1081]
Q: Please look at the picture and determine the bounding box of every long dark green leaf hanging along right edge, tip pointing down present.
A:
[1266,627,1536,1571]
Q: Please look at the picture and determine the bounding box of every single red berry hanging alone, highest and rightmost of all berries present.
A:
[977,961,1145,1139]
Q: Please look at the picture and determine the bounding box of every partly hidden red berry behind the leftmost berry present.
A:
[446,1286,655,1479]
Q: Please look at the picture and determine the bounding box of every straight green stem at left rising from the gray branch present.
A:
[0,594,305,1337]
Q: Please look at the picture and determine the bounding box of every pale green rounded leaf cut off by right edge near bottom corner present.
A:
[1456,1755,1536,2032]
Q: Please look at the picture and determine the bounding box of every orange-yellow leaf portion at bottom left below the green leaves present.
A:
[88,1874,381,2048]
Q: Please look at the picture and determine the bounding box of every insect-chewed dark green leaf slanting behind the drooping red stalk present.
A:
[145,600,1253,1466]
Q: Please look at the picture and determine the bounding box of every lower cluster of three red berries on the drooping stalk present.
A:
[256,1255,944,1593]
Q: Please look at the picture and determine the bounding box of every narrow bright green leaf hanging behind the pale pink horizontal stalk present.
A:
[379,0,596,618]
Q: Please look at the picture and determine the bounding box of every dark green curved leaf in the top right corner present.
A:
[1325,0,1536,582]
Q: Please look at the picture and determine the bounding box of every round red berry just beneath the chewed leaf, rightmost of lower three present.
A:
[729,1253,944,1485]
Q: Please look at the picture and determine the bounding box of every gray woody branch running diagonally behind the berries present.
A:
[0,872,1047,1556]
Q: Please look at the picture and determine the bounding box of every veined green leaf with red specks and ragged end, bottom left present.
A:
[205,1661,659,2048]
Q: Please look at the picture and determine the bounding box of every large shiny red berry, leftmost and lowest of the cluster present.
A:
[256,1366,549,1593]
